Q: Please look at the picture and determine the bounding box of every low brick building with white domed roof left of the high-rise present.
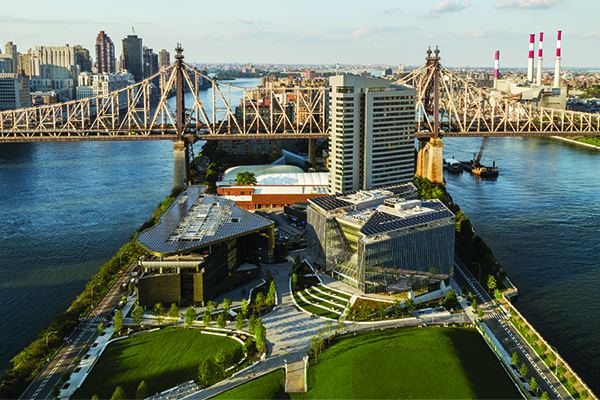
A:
[217,165,329,210]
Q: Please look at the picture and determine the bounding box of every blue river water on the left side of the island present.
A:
[0,79,259,374]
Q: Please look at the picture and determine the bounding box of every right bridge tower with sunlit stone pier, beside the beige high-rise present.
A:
[415,46,444,183]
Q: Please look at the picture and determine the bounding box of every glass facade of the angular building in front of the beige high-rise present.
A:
[307,199,455,294]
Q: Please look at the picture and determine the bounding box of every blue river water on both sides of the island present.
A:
[0,85,600,393]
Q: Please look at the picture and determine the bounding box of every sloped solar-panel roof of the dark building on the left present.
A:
[136,186,273,255]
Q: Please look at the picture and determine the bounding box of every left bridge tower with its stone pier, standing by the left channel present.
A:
[173,43,190,192]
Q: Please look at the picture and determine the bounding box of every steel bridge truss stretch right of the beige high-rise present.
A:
[397,63,600,137]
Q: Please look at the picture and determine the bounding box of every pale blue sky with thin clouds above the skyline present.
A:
[0,0,600,69]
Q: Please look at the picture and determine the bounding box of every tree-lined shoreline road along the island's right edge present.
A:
[454,257,571,399]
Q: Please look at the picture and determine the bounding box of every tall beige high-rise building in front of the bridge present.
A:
[329,75,415,194]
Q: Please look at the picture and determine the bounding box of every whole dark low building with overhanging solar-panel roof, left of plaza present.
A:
[136,186,274,307]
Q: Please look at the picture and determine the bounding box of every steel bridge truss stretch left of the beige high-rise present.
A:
[0,50,328,143]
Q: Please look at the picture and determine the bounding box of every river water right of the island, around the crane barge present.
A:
[444,138,600,394]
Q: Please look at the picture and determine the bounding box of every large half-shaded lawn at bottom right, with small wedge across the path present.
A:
[218,328,521,399]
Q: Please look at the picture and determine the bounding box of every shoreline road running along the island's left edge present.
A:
[19,262,136,399]
